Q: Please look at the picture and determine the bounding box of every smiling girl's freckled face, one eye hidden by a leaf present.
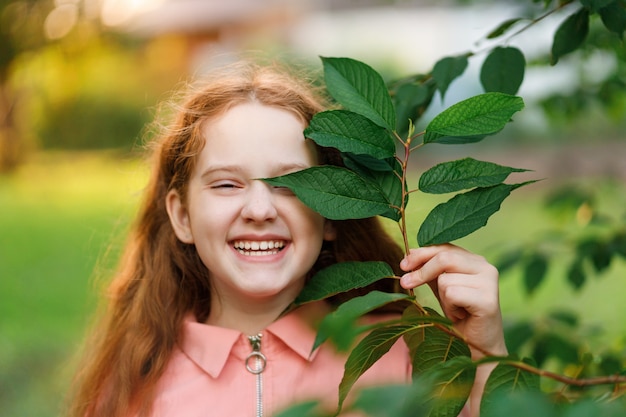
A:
[167,102,334,303]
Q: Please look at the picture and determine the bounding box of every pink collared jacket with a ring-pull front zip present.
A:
[152,302,411,417]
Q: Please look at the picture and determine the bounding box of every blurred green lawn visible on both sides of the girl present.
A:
[0,153,626,417]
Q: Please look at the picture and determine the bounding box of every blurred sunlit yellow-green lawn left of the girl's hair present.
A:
[0,154,143,417]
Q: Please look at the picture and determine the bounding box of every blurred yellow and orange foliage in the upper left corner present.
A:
[0,0,189,170]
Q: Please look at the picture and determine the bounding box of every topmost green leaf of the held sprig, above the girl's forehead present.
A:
[321,57,396,130]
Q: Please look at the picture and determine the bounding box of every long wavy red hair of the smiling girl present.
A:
[69,58,403,417]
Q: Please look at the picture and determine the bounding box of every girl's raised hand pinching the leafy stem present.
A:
[400,244,507,359]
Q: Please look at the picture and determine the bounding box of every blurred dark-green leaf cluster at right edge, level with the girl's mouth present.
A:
[496,183,626,295]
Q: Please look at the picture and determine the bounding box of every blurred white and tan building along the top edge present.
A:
[100,0,532,72]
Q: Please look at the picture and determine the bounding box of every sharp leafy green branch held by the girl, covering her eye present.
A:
[265,52,626,416]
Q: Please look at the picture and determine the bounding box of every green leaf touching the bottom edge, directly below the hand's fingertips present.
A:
[419,356,476,417]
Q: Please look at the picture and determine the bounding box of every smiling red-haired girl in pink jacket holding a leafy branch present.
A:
[71,58,506,417]
